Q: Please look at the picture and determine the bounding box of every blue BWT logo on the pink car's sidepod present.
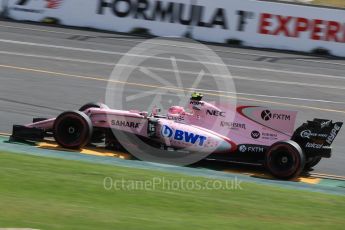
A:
[161,125,207,146]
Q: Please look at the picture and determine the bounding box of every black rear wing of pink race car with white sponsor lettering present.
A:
[291,119,343,157]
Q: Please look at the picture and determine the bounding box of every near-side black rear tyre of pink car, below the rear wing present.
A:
[265,141,305,180]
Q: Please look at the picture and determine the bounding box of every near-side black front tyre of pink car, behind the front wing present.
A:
[53,111,93,149]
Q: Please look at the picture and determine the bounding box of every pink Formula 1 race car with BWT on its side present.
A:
[11,95,343,179]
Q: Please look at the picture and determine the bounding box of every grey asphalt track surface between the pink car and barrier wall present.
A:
[0,21,345,176]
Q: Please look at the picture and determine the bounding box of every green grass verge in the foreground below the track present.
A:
[0,153,345,230]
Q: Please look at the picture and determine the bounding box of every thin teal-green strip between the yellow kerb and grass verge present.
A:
[0,137,345,195]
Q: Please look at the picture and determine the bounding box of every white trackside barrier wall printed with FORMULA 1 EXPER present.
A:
[2,0,345,57]
